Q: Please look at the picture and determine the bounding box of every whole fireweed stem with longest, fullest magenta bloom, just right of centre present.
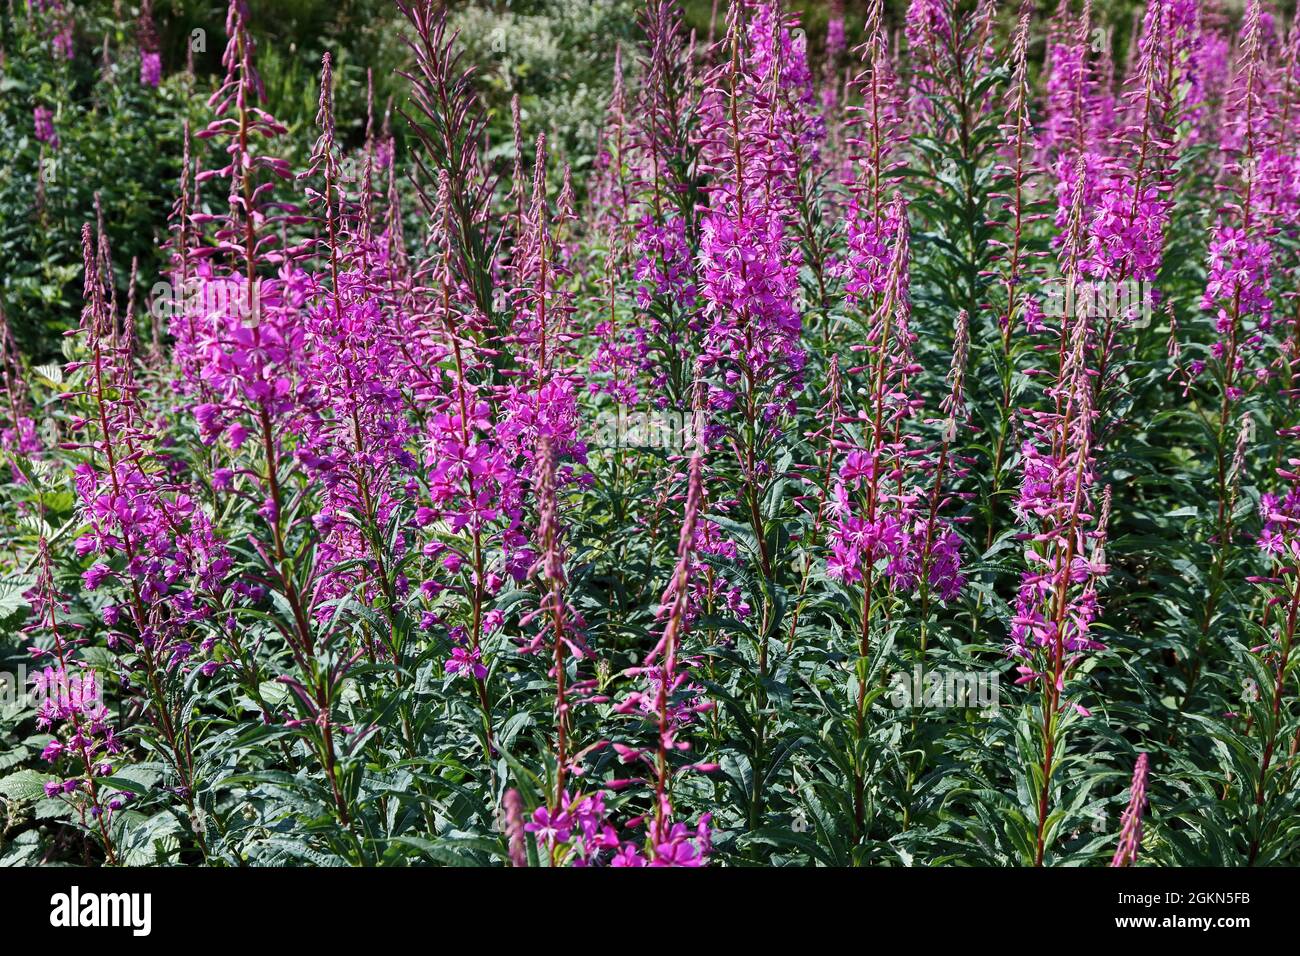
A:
[699,3,823,829]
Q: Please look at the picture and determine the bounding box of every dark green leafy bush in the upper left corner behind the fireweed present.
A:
[0,8,191,360]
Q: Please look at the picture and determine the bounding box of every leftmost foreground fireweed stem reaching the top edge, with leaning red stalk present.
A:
[185,0,364,827]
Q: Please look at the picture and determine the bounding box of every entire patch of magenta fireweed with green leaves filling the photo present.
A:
[0,0,1300,866]
